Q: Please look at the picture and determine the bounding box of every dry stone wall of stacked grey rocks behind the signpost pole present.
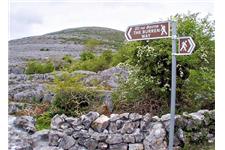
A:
[49,110,215,150]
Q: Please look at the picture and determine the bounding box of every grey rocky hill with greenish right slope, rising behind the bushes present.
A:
[8,27,124,66]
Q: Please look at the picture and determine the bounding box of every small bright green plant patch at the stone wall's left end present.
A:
[35,111,52,131]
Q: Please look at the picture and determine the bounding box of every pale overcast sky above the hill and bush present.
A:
[9,0,214,39]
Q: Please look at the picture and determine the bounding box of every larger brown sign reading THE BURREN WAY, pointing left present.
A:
[125,21,170,41]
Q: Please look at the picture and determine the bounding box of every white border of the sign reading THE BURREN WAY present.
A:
[124,20,172,41]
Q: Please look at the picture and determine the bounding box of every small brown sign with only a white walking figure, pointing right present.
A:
[178,36,195,55]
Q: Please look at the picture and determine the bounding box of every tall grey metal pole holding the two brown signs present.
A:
[169,21,177,150]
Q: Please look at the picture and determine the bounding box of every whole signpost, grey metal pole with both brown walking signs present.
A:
[125,21,195,150]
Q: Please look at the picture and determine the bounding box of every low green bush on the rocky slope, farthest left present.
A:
[25,61,55,74]
